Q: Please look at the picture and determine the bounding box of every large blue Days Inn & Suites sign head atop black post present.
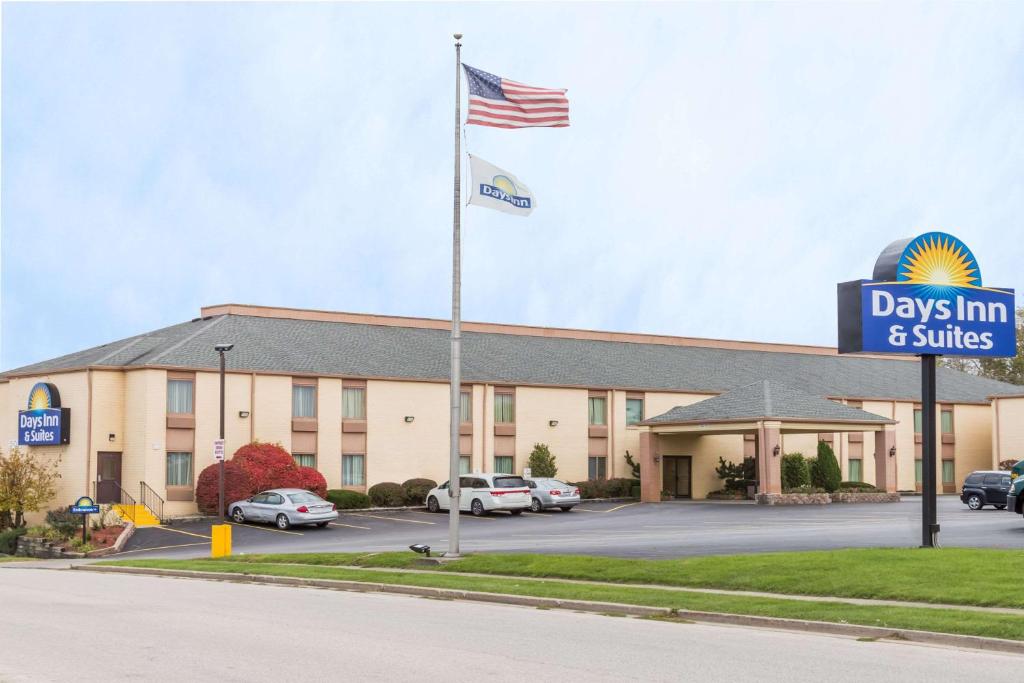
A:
[839,232,1017,356]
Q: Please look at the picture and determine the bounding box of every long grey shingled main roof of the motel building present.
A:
[0,314,1021,402]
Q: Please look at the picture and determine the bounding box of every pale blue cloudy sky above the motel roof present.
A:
[0,2,1024,369]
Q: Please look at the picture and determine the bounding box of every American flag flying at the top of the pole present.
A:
[463,65,569,128]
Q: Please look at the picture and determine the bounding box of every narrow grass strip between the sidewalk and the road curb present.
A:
[100,559,1024,640]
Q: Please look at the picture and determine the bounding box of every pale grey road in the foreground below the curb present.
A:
[0,565,1024,683]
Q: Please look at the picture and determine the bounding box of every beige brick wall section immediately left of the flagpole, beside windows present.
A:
[367,380,450,486]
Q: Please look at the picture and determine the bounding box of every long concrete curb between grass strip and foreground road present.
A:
[72,564,1024,654]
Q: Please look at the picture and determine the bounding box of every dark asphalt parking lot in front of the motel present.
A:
[123,497,1024,558]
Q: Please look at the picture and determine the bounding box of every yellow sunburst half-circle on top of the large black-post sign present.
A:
[896,232,981,288]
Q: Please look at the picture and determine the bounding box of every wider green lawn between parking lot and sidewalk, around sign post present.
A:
[182,548,1024,608]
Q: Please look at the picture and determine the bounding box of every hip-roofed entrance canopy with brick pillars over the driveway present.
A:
[639,380,896,503]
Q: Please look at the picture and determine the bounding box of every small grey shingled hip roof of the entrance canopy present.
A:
[640,380,893,425]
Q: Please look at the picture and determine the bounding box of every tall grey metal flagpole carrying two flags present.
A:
[444,33,462,557]
